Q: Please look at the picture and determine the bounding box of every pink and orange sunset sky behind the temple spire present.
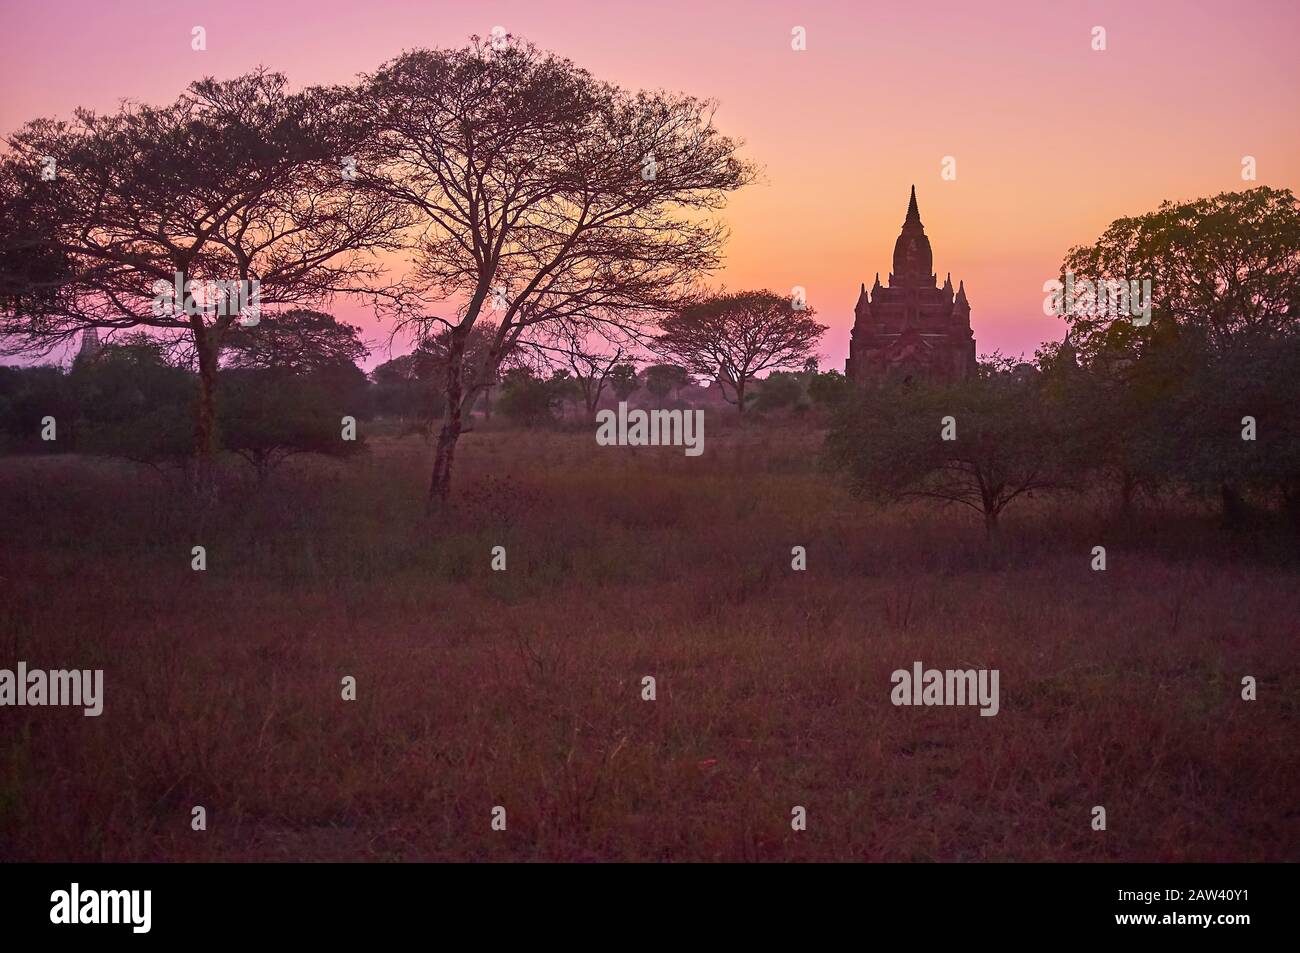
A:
[0,0,1300,369]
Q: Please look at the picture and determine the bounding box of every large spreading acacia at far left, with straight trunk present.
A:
[0,70,407,495]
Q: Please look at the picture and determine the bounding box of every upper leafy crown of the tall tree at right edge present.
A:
[1058,186,1300,363]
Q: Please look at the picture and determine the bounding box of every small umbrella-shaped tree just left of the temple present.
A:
[657,291,826,413]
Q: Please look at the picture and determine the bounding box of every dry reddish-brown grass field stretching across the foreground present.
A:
[0,425,1300,861]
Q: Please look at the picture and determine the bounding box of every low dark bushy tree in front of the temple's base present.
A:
[827,371,1071,536]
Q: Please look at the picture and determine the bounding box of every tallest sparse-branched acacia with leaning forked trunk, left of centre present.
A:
[359,36,751,511]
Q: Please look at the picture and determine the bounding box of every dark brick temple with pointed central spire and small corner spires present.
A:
[844,186,975,385]
